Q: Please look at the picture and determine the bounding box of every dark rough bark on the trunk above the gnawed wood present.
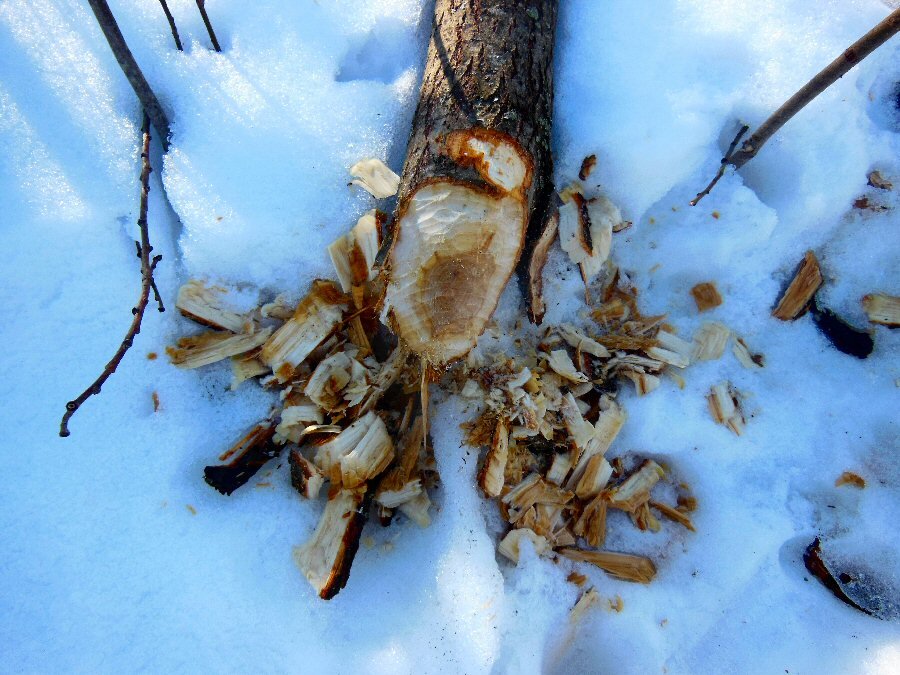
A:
[397,0,558,324]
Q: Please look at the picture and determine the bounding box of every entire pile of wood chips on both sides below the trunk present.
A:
[168,160,784,599]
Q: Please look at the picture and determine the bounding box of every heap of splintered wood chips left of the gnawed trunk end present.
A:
[168,199,438,599]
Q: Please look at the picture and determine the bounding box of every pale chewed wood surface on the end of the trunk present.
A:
[385,129,531,365]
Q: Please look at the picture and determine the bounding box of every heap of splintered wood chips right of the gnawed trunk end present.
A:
[452,260,704,583]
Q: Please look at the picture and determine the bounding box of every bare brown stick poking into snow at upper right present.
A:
[691,9,900,206]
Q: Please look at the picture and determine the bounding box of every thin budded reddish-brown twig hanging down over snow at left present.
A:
[59,111,166,438]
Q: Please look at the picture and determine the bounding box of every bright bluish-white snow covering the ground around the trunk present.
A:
[0,0,900,673]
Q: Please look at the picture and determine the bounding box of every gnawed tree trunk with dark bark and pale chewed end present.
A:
[385,0,558,366]
